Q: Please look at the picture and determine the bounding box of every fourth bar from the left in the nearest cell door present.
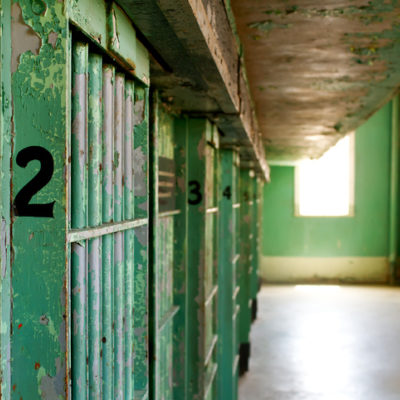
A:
[114,74,125,400]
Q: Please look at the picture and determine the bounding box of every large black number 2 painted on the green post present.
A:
[14,146,55,218]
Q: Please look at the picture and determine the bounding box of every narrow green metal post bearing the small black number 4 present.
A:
[217,149,239,400]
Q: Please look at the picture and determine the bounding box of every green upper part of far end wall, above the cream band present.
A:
[262,103,391,257]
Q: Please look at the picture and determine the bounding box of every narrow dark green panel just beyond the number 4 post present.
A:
[238,169,253,373]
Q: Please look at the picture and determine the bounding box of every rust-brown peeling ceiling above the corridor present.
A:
[231,0,400,162]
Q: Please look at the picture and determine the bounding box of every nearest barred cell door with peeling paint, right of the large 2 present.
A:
[68,39,148,400]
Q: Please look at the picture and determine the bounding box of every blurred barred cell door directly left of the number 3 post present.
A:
[151,97,186,400]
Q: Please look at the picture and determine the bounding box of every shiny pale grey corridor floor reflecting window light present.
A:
[239,286,400,400]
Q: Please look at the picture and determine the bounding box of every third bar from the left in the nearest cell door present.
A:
[102,65,115,399]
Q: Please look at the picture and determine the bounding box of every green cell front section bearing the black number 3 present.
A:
[187,119,219,399]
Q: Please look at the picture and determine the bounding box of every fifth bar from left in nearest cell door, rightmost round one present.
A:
[124,81,134,399]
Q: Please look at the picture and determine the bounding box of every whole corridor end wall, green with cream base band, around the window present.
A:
[260,102,392,283]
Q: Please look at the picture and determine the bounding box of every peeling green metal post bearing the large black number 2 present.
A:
[9,0,69,400]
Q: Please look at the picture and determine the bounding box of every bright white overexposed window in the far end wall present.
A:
[295,133,354,217]
